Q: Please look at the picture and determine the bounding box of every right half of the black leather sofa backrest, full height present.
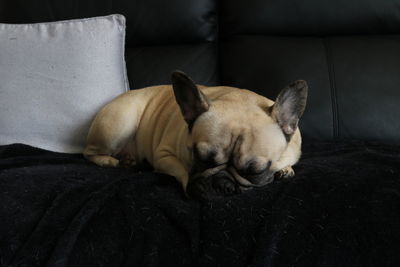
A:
[219,0,400,143]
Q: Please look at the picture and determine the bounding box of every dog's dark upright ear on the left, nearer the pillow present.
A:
[171,71,210,128]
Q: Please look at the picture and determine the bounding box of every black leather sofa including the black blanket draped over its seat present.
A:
[0,0,400,266]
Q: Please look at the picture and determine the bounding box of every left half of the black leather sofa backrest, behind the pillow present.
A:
[0,0,219,89]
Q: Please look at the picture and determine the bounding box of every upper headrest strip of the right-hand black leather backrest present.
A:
[220,0,400,36]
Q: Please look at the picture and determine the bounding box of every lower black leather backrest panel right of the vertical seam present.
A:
[330,35,400,142]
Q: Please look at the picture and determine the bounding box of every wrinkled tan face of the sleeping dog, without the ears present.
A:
[191,107,287,186]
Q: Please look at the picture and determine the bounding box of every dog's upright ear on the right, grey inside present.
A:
[270,80,308,138]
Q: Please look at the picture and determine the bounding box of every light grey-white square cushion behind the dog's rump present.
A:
[0,15,129,153]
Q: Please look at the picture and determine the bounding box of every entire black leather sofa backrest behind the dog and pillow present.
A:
[0,0,400,143]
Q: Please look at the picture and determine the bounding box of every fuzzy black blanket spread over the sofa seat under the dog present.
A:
[0,143,400,267]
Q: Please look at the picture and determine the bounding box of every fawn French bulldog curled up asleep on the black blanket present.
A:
[83,71,308,198]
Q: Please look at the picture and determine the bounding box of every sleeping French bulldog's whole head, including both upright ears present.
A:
[172,71,307,199]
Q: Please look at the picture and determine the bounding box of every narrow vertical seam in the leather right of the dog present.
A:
[323,38,339,140]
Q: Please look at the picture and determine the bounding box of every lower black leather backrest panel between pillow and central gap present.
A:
[126,43,218,88]
